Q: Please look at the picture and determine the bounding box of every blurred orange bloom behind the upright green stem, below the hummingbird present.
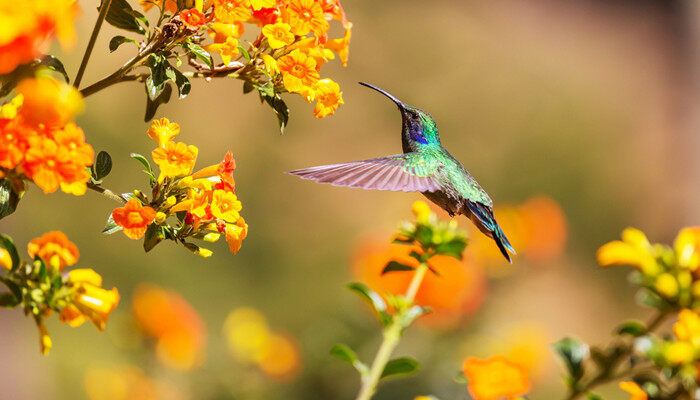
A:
[352,239,486,325]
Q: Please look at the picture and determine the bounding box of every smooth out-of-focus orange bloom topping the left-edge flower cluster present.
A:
[17,78,83,127]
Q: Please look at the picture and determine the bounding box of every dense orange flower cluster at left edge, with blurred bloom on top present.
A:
[0,78,94,195]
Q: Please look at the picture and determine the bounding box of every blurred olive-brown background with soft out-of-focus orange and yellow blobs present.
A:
[0,0,700,400]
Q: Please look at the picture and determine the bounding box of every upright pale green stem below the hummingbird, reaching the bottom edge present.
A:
[356,263,428,400]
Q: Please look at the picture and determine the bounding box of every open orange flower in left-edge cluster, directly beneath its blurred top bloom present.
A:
[24,138,84,193]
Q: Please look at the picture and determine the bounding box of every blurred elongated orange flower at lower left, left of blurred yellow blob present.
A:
[132,284,206,370]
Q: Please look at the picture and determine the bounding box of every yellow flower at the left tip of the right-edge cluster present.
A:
[596,228,660,276]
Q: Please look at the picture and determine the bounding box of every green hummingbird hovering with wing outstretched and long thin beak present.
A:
[288,82,515,262]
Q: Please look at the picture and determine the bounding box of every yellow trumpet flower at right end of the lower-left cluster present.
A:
[61,268,119,331]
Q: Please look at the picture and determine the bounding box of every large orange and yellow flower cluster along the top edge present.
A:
[127,0,352,123]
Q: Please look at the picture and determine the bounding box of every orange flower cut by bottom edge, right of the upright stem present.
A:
[462,356,530,400]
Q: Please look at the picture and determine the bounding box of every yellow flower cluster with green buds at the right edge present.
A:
[597,227,700,309]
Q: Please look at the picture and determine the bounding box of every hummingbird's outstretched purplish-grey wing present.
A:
[288,153,441,192]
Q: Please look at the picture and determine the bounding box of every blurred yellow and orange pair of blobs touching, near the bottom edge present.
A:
[223,307,300,380]
